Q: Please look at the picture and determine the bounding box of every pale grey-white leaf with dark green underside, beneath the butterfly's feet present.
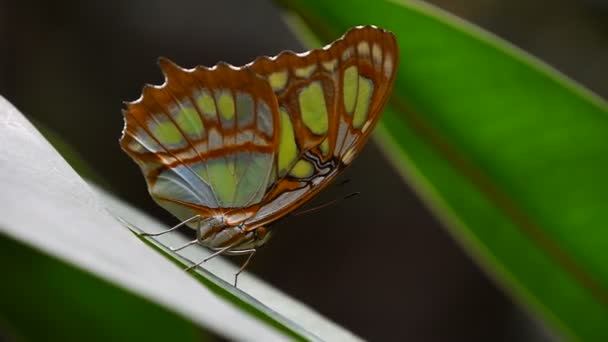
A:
[0,97,357,341]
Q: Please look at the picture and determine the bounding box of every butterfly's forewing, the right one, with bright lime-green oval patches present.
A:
[242,26,398,227]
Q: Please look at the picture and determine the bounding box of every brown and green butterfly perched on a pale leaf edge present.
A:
[120,26,398,286]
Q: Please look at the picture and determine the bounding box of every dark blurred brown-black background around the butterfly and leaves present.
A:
[0,0,608,341]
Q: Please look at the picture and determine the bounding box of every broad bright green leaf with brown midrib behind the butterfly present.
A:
[281,0,608,340]
